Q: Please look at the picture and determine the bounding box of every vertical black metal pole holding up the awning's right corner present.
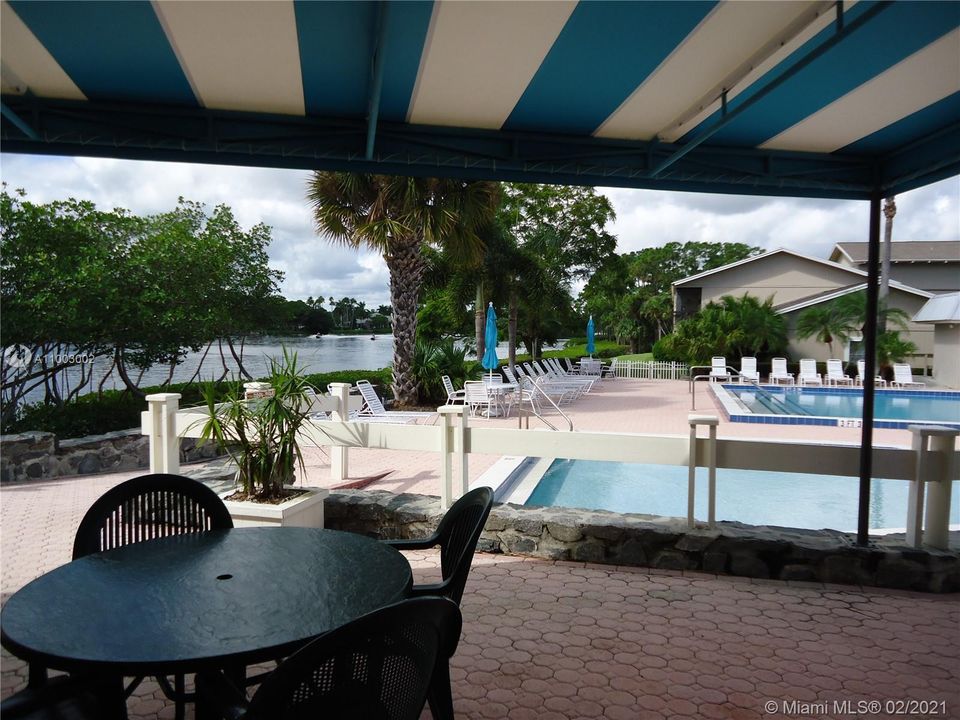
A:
[857,191,881,545]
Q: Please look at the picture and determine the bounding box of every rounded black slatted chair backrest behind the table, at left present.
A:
[73,473,233,560]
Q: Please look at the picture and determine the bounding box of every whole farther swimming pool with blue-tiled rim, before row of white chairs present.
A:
[711,384,960,429]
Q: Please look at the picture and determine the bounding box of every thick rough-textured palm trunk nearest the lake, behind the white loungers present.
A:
[384,237,424,405]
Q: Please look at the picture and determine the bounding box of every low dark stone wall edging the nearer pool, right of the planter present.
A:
[325,490,960,593]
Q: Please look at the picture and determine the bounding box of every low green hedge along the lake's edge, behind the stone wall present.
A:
[3,368,391,438]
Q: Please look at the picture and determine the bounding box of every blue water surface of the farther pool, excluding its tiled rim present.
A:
[723,385,960,427]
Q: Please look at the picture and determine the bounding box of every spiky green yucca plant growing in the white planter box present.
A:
[200,348,312,501]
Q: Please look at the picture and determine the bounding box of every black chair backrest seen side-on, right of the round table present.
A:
[437,487,493,605]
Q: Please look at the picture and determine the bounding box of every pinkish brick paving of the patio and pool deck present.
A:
[0,380,960,720]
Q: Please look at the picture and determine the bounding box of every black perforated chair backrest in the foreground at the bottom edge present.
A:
[246,597,461,720]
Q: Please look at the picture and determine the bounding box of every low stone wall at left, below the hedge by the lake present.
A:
[0,428,217,483]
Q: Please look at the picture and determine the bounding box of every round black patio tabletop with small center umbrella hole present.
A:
[0,527,413,716]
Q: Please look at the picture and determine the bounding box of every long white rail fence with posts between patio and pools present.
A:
[141,384,960,549]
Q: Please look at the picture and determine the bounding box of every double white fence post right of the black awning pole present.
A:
[907,425,960,550]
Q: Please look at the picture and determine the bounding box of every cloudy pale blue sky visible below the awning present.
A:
[0,154,960,307]
